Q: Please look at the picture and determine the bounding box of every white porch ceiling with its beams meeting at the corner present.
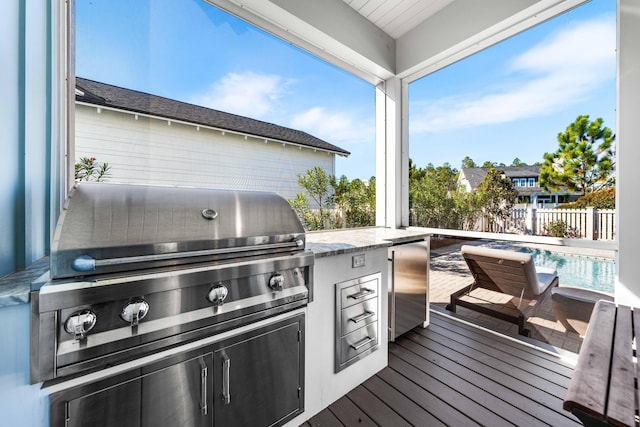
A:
[206,0,586,84]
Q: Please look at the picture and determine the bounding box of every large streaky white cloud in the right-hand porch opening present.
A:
[411,17,616,132]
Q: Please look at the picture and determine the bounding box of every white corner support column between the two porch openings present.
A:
[376,78,409,228]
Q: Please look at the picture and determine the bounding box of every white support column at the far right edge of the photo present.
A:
[615,0,640,307]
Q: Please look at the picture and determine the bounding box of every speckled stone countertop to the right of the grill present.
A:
[306,227,431,257]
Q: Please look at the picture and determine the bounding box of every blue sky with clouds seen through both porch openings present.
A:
[76,0,615,179]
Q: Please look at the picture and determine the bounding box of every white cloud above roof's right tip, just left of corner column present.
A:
[290,107,375,144]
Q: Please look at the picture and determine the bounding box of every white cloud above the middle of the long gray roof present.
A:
[190,71,292,118]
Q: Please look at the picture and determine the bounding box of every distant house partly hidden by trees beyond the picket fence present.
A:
[458,166,579,205]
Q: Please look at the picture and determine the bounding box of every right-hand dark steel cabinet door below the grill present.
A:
[213,318,304,427]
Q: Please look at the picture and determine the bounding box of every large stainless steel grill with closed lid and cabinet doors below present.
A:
[31,183,314,425]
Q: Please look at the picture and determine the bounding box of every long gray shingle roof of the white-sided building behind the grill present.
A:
[76,77,351,156]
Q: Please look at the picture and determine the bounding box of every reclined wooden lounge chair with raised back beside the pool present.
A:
[447,245,558,336]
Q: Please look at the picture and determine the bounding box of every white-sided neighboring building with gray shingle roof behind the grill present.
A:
[75,78,350,199]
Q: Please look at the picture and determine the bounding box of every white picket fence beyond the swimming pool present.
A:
[501,207,616,240]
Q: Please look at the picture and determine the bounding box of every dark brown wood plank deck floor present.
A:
[303,312,582,427]
